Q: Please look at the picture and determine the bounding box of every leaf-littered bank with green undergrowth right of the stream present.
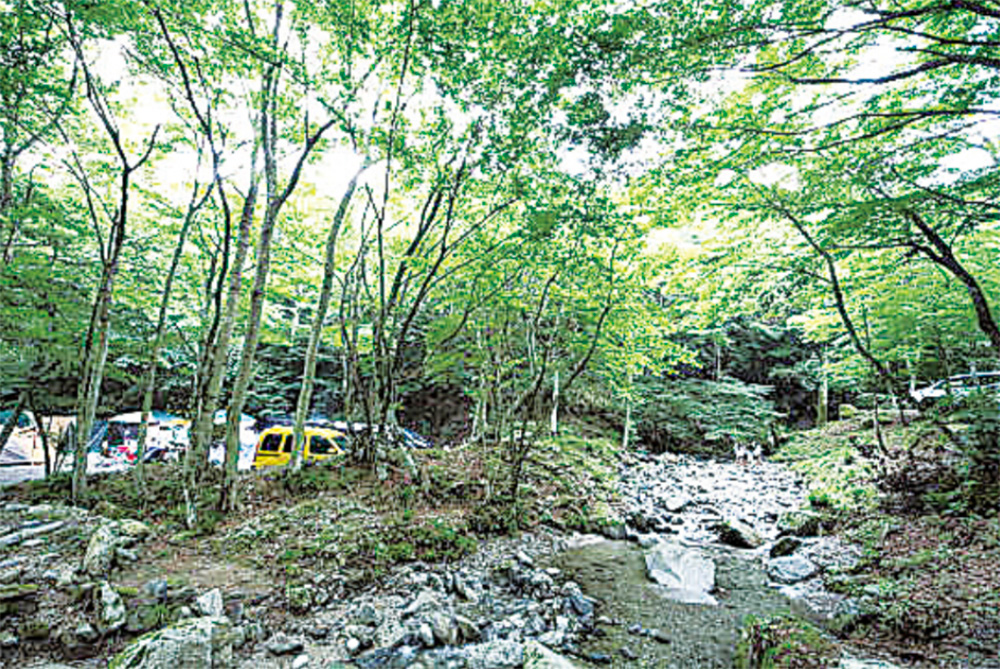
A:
[774,416,1000,667]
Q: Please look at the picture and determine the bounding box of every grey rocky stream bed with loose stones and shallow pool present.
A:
[0,454,908,669]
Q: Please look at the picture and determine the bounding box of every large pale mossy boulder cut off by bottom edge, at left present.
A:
[108,617,236,669]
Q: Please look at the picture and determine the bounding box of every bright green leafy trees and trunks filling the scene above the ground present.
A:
[0,0,1000,506]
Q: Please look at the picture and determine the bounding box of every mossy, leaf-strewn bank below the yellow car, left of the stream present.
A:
[0,430,617,666]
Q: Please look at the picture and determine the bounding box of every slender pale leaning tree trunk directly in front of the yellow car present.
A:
[292,166,368,471]
